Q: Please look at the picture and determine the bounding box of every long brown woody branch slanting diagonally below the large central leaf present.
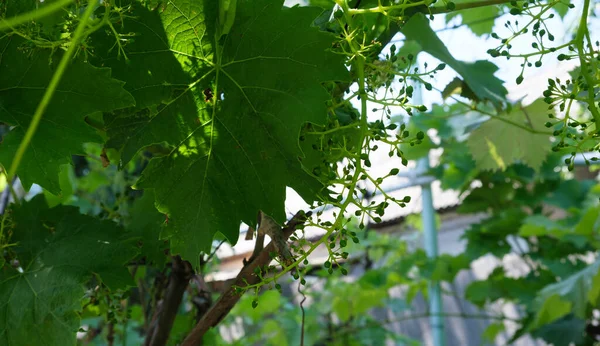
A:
[181,211,309,346]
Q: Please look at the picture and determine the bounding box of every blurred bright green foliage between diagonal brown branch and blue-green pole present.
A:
[216,228,423,346]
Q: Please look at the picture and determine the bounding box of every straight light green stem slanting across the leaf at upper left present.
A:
[8,0,98,181]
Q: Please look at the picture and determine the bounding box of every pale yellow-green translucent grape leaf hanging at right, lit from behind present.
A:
[467,100,551,171]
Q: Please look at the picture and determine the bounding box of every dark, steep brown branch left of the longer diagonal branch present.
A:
[145,256,194,346]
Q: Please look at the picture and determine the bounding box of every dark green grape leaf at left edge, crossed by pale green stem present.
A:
[0,35,134,195]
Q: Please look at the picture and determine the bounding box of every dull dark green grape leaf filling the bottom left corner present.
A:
[0,195,136,345]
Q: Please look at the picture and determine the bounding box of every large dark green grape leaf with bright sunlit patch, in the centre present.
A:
[98,0,348,263]
